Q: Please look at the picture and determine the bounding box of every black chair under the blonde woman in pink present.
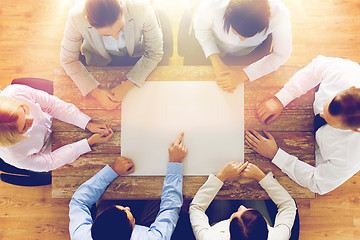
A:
[0,78,53,186]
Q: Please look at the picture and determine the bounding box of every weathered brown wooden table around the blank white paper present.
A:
[52,66,315,199]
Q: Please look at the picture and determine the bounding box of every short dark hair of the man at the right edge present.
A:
[329,88,360,129]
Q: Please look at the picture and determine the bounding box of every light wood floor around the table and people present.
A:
[0,0,360,240]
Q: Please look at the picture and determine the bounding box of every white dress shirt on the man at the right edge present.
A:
[272,56,360,194]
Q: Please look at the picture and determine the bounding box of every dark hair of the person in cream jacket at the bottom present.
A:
[230,209,269,240]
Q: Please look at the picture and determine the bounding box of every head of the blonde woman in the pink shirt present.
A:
[0,96,34,147]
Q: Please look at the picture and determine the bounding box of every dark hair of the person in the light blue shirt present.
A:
[91,205,133,240]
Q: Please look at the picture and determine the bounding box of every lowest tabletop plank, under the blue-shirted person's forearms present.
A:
[52,173,315,199]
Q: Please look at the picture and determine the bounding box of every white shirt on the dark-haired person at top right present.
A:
[194,0,292,81]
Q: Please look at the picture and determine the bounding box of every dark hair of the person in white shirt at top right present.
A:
[223,0,270,38]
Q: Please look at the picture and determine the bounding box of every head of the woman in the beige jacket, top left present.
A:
[84,0,125,39]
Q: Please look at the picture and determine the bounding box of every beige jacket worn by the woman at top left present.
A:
[60,0,163,96]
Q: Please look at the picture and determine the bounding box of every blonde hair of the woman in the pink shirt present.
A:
[0,96,29,147]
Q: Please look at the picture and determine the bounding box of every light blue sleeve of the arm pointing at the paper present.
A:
[148,163,183,240]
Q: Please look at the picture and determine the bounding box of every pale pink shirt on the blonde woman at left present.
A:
[0,85,91,172]
